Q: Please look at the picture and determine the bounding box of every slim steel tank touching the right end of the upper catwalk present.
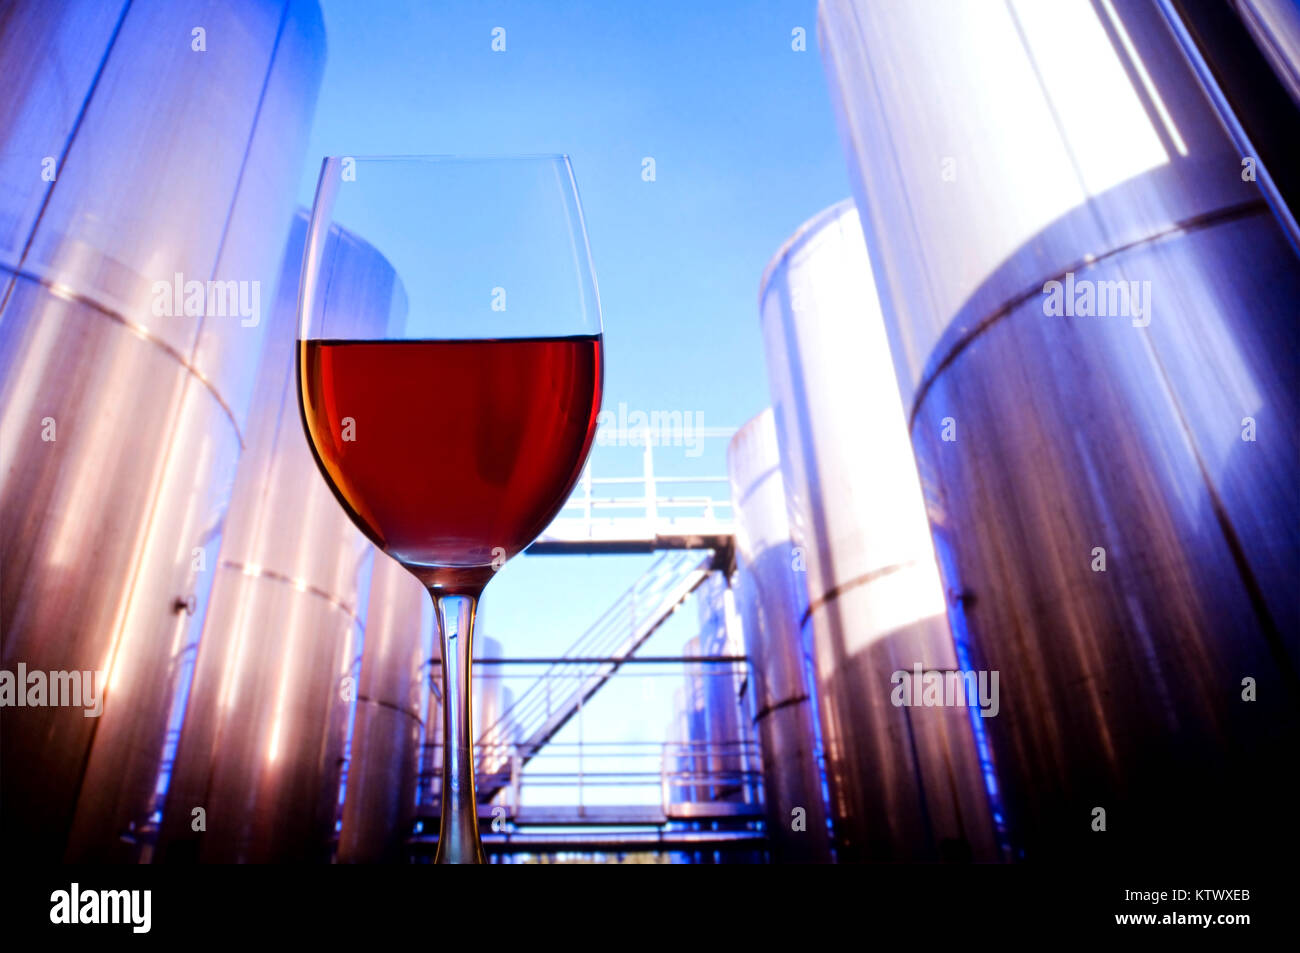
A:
[727,410,831,863]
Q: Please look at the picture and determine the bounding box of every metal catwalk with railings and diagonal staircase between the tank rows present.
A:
[408,428,766,859]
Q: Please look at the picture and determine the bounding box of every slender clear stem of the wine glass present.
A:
[429,589,488,863]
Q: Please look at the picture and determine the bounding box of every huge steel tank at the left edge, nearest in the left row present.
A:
[0,0,324,861]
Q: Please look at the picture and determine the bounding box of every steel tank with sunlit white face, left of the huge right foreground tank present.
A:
[759,208,997,862]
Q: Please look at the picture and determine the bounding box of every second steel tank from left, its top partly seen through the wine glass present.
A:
[157,216,406,863]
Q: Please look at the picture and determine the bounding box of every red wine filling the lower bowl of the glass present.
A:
[299,334,602,593]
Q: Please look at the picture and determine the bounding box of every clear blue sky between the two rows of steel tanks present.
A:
[300,0,849,774]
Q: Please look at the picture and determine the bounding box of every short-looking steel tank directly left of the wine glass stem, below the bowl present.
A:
[338,555,433,863]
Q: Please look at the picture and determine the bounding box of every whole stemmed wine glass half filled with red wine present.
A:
[298,156,603,863]
